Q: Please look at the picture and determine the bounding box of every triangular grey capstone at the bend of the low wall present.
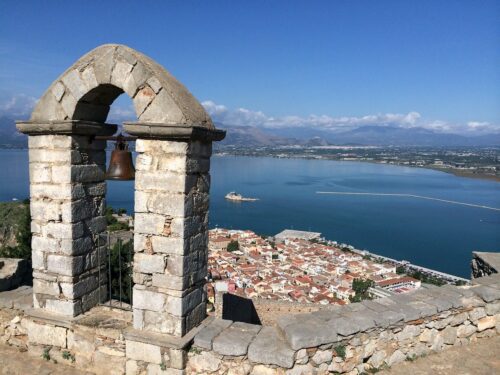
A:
[248,327,294,368]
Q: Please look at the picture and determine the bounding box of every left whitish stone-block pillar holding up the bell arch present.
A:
[18,121,113,317]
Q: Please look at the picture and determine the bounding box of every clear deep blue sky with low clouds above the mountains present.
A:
[0,0,500,133]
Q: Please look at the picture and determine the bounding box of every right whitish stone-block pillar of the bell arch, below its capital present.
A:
[133,139,212,337]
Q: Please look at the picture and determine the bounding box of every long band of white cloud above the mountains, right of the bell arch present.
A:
[201,100,500,134]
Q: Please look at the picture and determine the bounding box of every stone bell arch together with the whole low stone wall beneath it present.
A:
[0,44,500,375]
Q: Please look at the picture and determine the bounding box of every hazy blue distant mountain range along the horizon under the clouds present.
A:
[0,116,500,147]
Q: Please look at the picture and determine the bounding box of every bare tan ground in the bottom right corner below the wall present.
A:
[382,336,500,375]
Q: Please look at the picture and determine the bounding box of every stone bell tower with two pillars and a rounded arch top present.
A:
[17,45,225,346]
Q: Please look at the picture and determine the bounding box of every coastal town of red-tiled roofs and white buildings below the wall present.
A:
[208,228,446,305]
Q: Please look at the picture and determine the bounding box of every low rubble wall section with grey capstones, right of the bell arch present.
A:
[187,275,500,375]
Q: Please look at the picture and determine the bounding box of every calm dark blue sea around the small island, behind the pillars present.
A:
[0,150,500,277]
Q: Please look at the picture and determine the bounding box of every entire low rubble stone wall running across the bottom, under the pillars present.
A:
[0,274,500,375]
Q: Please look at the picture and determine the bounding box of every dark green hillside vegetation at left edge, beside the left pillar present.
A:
[0,199,31,260]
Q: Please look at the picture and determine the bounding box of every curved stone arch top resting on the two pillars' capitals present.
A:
[30,44,214,129]
